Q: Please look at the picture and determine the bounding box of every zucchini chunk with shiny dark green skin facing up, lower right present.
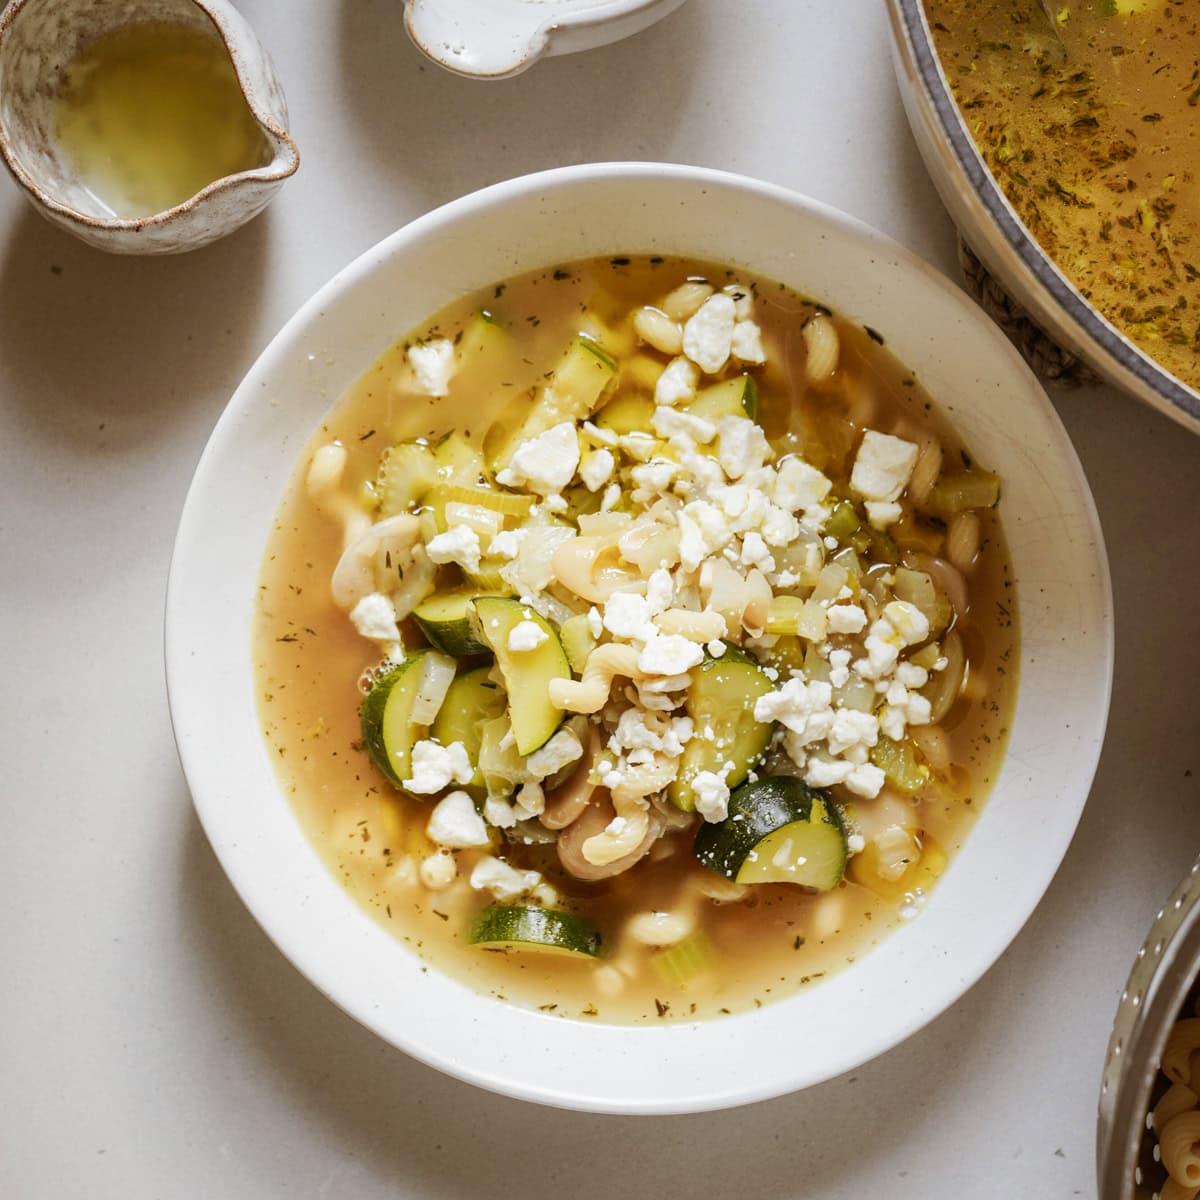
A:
[692,775,848,892]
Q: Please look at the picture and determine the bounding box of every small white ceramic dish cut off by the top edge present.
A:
[404,0,683,79]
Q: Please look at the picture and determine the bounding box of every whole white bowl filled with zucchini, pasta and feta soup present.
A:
[168,164,1110,1111]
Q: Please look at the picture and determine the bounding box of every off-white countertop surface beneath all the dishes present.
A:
[0,0,1200,1200]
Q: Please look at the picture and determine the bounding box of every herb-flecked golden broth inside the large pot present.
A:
[925,0,1200,388]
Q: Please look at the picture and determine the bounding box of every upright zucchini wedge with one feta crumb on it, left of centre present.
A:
[473,596,571,755]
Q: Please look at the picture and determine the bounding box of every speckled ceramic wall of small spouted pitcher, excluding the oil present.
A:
[0,0,300,254]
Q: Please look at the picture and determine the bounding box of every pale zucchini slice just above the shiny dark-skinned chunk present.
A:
[667,646,774,812]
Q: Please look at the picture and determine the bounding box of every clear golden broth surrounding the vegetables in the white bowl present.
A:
[253,259,1016,1022]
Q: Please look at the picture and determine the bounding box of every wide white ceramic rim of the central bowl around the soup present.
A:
[166,163,1112,1112]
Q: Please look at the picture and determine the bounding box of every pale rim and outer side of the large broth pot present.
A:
[889,0,1200,424]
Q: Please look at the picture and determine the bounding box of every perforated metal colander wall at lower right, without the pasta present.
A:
[1096,859,1200,1200]
